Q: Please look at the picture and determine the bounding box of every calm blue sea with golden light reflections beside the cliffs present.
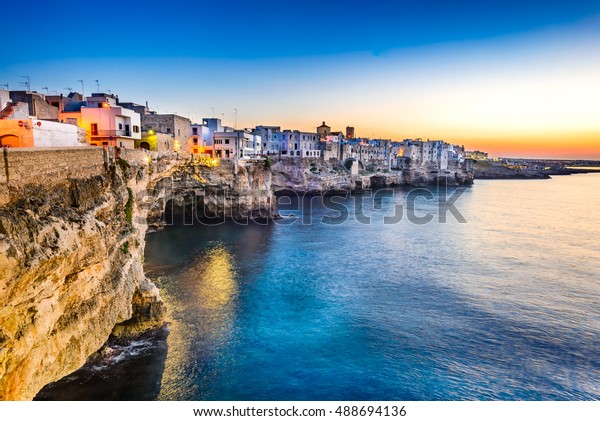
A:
[40,174,600,400]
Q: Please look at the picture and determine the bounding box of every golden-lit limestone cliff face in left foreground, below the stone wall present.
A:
[0,159,163,400]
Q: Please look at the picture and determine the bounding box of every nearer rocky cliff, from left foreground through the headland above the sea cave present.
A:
[0,151,274,400]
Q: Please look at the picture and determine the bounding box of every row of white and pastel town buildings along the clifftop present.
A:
[0,87,474,170]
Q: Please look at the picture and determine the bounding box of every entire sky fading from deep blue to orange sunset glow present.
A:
[0,0,600,159]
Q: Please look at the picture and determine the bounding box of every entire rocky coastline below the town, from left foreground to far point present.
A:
[0,149,596,399]
